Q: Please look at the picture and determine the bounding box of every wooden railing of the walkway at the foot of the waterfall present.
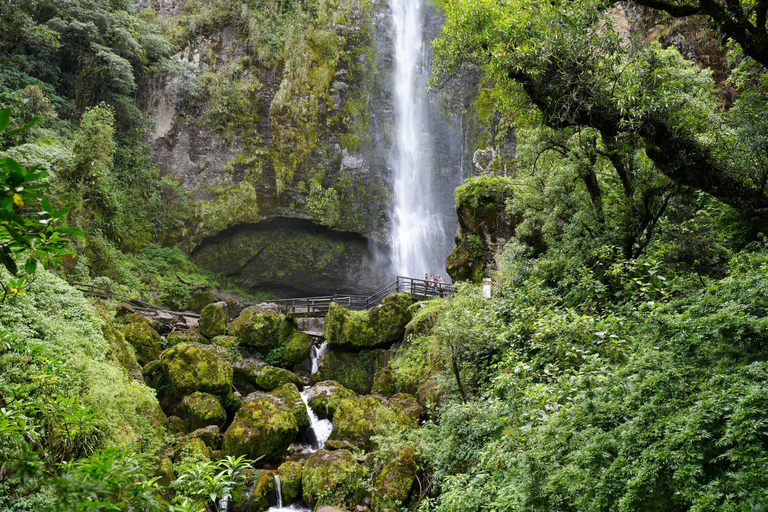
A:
[270,276,456,316]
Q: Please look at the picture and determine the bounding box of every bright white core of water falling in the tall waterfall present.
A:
[392,0,446,277]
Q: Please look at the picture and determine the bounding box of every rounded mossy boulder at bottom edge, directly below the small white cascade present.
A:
[301,450,367,508]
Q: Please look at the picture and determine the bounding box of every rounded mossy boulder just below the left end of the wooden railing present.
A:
[229,306,296,350]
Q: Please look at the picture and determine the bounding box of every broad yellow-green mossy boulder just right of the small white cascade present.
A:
[329,395,418,451]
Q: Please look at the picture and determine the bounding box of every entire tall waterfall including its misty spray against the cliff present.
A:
[391,0,461,280]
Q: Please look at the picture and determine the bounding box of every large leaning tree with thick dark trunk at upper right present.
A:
[432,0,768,233]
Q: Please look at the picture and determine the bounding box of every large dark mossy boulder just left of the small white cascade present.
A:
[222,384,309,461]
